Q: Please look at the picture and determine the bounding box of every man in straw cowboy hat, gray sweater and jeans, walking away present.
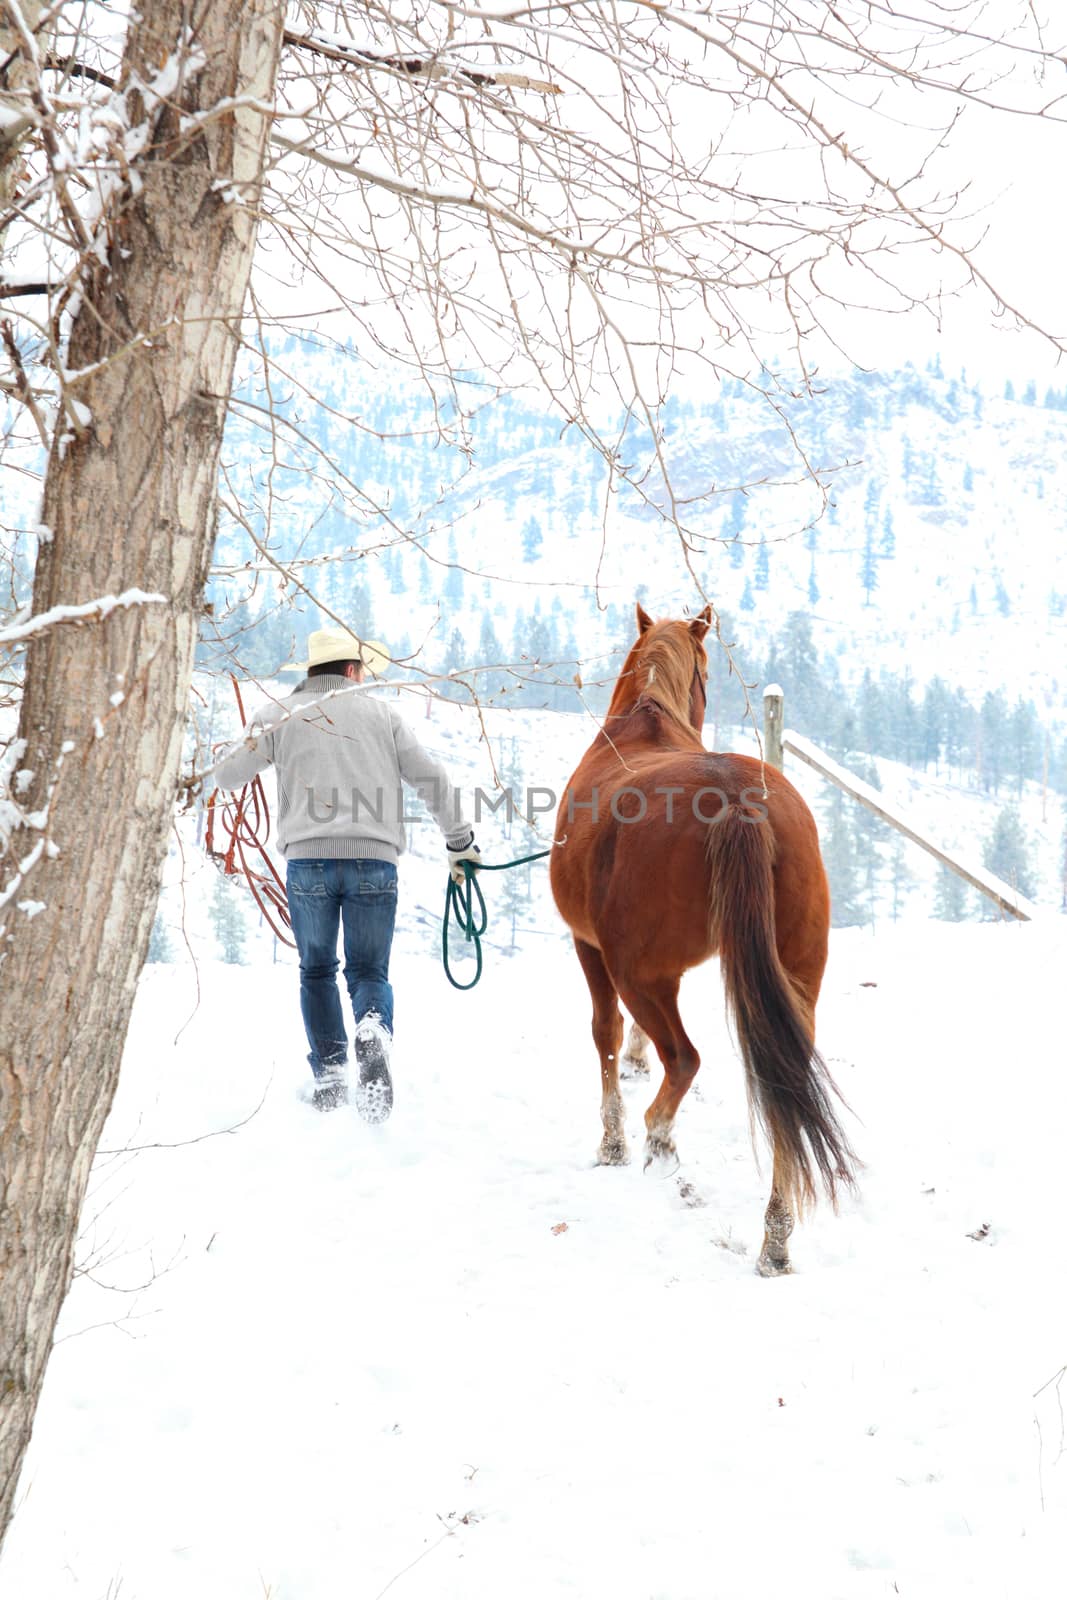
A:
[214,629,478,1122]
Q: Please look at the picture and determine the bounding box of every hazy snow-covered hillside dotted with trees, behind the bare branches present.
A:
[195,352,1067,728]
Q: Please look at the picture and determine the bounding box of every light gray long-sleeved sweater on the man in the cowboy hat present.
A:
[214,674,470,861]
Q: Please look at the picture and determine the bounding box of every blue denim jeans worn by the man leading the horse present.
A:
[285,861,397,1077]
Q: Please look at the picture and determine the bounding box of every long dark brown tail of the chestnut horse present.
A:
[705,802,856,1214]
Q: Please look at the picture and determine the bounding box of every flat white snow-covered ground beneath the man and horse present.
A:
[0,883,1067,1600]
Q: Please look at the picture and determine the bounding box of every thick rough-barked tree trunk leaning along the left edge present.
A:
[0,0,285,1533]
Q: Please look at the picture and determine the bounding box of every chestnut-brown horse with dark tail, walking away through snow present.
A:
[550,605,854,1277]
